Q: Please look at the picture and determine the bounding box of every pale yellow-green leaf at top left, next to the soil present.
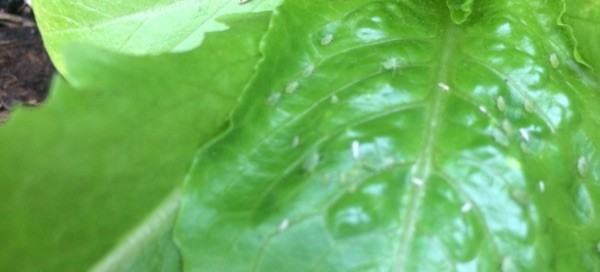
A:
[34,0,281,75]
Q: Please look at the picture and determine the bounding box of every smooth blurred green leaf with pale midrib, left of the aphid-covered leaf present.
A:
[0,13,270,271]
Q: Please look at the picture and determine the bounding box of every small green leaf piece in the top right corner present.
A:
[563,0,600,79]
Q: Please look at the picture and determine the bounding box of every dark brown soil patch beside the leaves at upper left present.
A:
[0,0,54,123]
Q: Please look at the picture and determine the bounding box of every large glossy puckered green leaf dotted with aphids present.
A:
[175,0,600,272]
